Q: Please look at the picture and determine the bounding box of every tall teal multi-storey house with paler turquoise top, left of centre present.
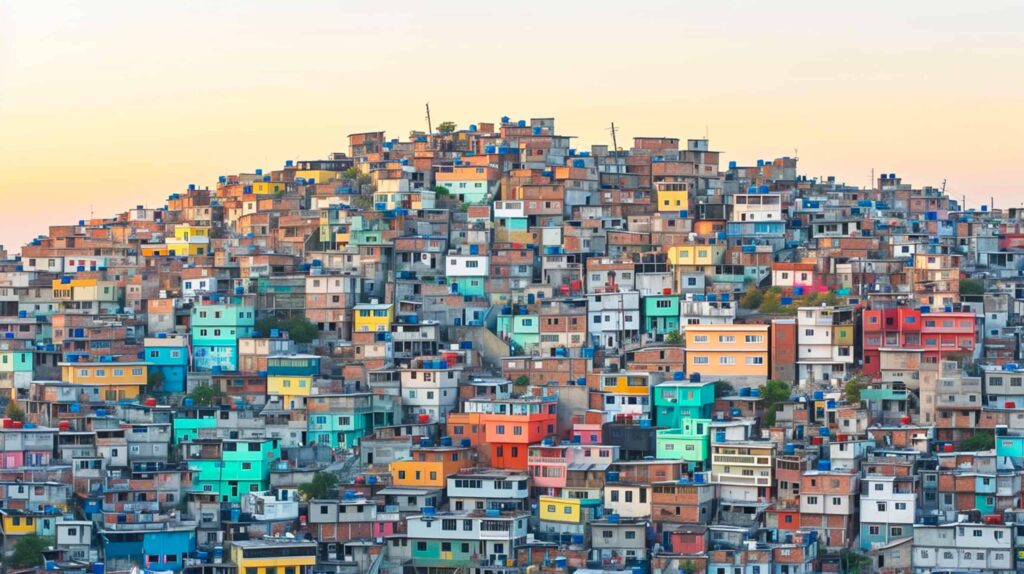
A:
[190,302,256,370]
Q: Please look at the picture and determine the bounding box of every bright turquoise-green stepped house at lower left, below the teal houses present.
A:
[182,439,281,502]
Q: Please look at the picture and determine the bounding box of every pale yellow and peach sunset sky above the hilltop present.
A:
[0,0,1024,251]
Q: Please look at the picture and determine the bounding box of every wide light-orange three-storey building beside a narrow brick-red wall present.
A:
[685,324,768,384]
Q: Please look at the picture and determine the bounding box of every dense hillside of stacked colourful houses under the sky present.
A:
[0,118,1024,574]
